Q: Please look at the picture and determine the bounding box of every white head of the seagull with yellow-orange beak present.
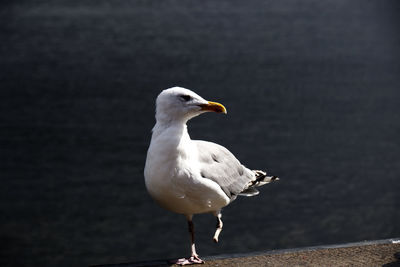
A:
[156,87,226,123]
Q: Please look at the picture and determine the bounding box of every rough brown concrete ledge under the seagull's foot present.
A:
[92,238,400,267]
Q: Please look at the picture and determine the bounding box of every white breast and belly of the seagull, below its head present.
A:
[144,125,229,214]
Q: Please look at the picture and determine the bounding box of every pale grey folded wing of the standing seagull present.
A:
[194,140,258,200]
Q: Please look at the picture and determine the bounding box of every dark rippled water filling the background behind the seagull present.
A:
[0,0,400,266]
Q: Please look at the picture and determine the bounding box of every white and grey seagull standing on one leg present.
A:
[144,87,279,265]
